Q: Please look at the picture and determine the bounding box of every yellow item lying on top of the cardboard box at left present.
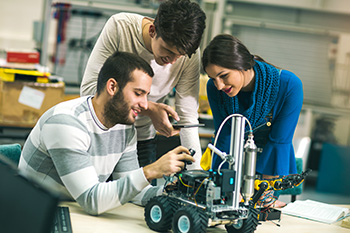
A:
[0,68,51,83]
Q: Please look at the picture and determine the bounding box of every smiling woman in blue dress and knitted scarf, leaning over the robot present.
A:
[202,35,303,206]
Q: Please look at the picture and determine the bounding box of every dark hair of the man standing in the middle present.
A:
[154,0,206,57]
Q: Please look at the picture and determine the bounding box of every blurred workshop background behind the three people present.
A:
[0,0,350,204]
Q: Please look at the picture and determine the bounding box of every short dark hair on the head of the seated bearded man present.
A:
[97,51,154,95]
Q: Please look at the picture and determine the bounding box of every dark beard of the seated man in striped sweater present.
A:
[103,91,134,127]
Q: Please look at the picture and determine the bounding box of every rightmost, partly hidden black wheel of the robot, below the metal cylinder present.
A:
[225,206,259,233]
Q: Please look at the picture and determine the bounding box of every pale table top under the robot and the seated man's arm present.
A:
[61,202,350,233]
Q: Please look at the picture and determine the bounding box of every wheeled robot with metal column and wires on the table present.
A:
[145,114,310,233]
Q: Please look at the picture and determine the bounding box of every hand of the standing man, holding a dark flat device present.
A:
[141,101,180,137]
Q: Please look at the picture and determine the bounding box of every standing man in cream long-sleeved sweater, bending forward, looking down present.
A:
[81,0,206,169]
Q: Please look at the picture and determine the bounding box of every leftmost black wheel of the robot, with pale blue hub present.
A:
[145,196,176,232]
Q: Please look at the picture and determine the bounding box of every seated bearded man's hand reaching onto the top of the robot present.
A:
[143,146,195,182]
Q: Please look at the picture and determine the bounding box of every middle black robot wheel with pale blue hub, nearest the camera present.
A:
[173,206,208,233]
